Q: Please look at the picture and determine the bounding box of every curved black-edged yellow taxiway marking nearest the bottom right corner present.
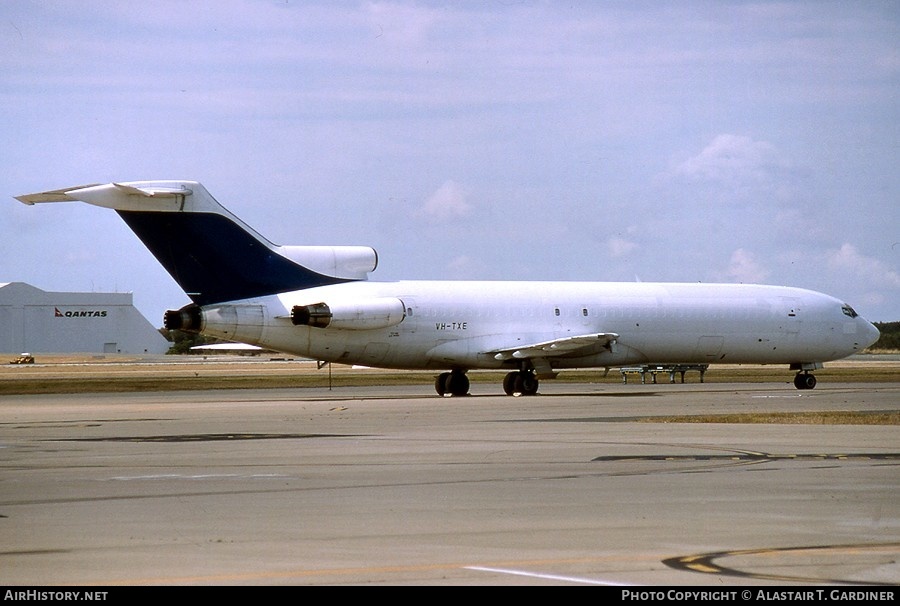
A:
[663,543,900,586]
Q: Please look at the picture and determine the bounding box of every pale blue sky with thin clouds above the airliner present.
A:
[0,0,900,325]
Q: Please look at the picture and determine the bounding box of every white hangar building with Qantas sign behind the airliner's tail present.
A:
[0,282,171,354]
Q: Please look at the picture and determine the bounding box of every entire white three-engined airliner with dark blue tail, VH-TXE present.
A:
[17,181,879,395]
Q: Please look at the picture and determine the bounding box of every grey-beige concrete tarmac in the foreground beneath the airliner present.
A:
[0,368,900,587]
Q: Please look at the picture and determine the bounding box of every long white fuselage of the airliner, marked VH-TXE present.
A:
[203,281,878,369]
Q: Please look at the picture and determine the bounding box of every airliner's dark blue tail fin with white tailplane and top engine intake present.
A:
[18,181,378,305]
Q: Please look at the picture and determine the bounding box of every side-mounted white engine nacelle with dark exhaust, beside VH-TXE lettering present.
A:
[291,297,406,330]
